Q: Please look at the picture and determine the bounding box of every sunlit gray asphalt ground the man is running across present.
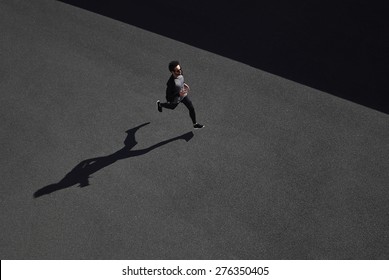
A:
[0,0,389,259]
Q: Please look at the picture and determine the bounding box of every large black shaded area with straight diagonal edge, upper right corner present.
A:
[60,0,389,113]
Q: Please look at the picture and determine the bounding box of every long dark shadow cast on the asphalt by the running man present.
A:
[34,122,193,198]
